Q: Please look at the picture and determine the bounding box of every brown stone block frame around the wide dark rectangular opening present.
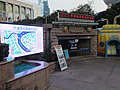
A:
[51,27,97,55]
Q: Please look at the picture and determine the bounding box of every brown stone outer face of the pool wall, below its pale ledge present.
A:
[6,68,49,90]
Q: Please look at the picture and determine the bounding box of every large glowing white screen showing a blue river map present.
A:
[0,24,43,57]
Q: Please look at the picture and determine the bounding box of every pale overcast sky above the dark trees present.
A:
[25,0,107,13]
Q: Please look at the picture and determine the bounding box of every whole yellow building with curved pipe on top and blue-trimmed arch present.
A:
[98,15,120,57]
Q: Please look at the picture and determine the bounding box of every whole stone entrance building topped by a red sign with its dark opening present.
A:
[50,12,98,57]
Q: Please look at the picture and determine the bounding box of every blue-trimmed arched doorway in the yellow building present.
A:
[105,39,120,57]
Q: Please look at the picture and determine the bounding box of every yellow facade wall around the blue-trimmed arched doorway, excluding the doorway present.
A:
[98,25,120,55]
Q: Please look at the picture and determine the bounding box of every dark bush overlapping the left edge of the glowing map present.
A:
[0,43,9,61]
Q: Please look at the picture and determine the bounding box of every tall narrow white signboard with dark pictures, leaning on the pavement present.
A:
[55,45,68,71]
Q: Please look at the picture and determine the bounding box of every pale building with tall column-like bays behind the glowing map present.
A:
[0,0,37,22]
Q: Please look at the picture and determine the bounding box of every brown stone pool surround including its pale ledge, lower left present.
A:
[0,60,49,90]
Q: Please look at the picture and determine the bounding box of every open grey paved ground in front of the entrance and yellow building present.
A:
[47,57,120,90]
